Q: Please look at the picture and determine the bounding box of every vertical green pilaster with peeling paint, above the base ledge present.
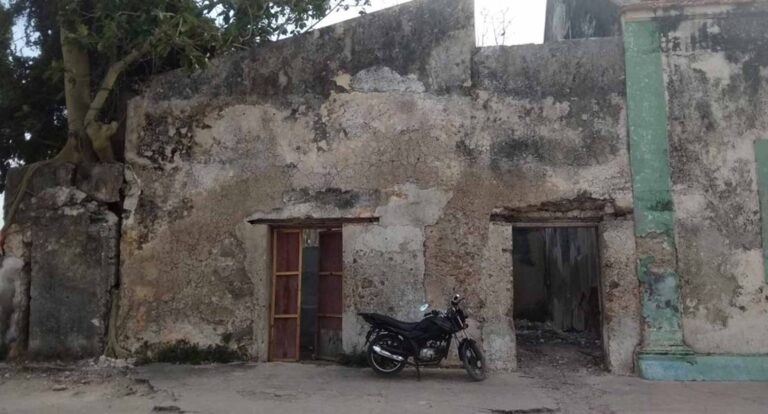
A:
[624,21,690,353]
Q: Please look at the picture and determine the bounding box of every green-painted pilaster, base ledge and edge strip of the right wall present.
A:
[624,16,768,381]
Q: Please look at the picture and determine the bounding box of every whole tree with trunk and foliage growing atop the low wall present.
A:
[0,0,369,247]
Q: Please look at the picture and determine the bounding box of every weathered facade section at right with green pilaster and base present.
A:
[624,2,768,379]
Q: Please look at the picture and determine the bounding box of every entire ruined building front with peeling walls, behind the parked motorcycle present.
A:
[0,0,768,380]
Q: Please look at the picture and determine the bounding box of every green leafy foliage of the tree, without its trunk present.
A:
[0,0,369,191]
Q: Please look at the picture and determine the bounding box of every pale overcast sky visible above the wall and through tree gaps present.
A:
[0,0,547,226]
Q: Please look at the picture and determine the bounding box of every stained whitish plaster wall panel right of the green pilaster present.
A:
[658,2,768,353]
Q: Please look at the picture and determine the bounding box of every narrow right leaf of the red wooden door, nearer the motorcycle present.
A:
[316,229,344,358]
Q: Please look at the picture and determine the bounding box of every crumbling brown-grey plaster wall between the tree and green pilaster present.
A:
[118,0,639,368]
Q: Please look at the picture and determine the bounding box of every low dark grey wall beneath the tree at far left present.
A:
[0,164,123,359]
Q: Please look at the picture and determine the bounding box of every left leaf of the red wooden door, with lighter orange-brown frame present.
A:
[269,229,302,361]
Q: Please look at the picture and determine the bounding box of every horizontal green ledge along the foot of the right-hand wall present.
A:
[637,353,768,381]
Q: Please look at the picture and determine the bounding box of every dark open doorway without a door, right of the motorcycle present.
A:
[513,225,604,370]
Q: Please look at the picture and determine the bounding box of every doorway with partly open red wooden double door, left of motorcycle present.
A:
[269,227,343,361]
